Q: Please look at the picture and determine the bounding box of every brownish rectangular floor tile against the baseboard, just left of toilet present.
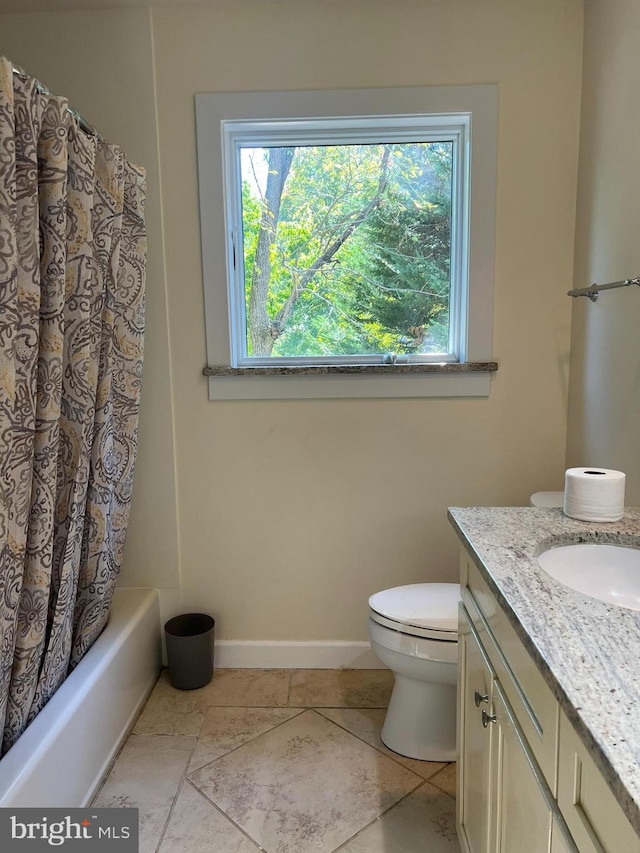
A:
[289,669,393,708]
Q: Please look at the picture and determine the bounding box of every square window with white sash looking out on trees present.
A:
[230,125,468,367]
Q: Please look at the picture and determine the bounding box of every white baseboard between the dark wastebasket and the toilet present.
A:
[214,640,386,669]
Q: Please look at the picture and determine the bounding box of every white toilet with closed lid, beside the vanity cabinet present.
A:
[368,583,460,761]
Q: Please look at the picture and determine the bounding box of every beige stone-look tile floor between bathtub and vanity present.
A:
[94,669,460,853]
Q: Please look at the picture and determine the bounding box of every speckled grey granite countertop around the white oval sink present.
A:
[449,507,640,834]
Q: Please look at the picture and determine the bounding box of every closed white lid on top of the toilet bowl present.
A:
[369,583,460,634]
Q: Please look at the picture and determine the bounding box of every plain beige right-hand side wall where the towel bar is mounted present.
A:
[567,0,640,506]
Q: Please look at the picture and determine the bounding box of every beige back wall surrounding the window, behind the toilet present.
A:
[0,0,582,640]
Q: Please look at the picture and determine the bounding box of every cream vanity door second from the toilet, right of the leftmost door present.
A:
[491,681,553,853]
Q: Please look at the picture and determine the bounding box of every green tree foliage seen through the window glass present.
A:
[242,143,451,356]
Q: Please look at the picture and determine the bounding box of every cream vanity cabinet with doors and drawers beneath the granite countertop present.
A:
[457,550,640,853]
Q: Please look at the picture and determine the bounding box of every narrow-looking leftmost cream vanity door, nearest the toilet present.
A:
[457,607,492,853]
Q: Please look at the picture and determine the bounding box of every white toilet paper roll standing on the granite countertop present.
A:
[563,468,626,521]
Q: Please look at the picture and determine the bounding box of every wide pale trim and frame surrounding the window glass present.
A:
[196,85,498,399]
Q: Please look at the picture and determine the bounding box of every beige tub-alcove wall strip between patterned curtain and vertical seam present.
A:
[0,9,178,588]
